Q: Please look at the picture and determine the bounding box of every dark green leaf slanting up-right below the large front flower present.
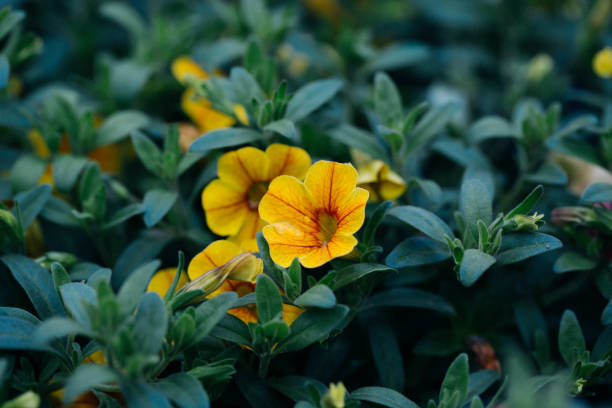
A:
[274,305,349,354]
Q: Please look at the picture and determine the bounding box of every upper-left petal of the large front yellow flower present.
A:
[259,176,318,232]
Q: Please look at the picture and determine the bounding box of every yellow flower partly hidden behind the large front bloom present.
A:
[202,144,310,251]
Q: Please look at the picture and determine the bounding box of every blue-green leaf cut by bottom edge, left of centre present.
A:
[153,373,210,408]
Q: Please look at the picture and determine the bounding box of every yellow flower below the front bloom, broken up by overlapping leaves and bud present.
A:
[187,240,303,324]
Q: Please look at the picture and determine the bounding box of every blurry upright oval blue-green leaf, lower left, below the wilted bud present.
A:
[134,292,168,354]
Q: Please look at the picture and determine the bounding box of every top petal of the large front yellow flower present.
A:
[304,160,357,214]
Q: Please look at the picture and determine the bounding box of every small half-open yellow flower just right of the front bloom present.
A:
[357,160,406,201]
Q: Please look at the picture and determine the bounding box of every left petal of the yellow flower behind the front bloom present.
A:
[202,179,249,235]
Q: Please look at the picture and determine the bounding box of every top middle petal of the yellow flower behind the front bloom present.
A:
[217,147,270,191]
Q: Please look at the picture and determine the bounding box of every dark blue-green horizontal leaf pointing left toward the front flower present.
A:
[385,237,451,268]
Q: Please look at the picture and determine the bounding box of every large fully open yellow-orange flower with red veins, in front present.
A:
[259,161,369,268]
